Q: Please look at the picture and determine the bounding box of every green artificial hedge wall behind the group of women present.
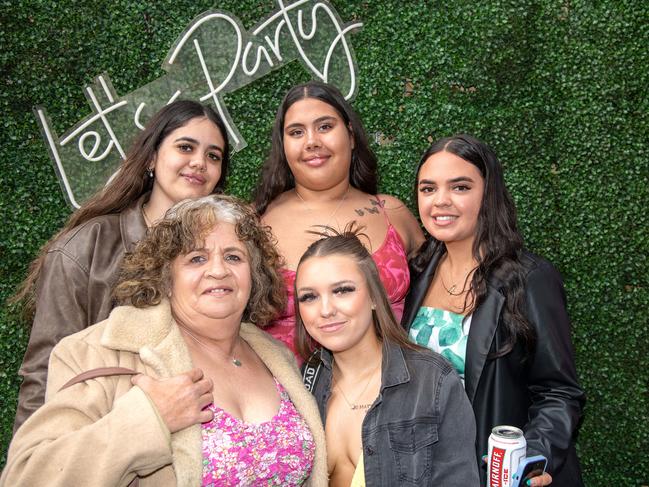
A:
[0,0,649,486]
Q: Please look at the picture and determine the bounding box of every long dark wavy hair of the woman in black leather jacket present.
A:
[411,134,536,358]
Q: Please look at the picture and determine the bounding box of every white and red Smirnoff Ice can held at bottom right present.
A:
[487,426,527,487]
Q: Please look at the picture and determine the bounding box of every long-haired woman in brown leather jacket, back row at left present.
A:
[14,100,229,431]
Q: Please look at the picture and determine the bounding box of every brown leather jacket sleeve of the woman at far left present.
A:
[14,250,90,433]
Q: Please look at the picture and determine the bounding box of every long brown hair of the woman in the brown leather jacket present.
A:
[9,100,230,319]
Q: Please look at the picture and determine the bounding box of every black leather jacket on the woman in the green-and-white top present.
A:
[402,246,585,487]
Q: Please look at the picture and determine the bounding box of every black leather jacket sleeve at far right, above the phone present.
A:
[524,261,585,474]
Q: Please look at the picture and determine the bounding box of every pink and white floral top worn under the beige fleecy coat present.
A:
[202,379,315,486]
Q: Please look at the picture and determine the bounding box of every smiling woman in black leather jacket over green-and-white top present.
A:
[402,135,585,487]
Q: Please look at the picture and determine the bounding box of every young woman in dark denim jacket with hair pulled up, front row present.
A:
[295,228,479,487]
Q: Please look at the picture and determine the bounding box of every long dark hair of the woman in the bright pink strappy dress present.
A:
[253,81,377,215]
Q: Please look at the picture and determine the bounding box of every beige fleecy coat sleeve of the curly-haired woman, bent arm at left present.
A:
[0,340,172,487]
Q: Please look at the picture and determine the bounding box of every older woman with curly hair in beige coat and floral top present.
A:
[0,195,327,487]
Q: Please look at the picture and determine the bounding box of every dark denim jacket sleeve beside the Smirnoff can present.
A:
[430,372,480,487]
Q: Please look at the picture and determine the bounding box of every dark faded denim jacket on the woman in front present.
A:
[313,343,480,487]
